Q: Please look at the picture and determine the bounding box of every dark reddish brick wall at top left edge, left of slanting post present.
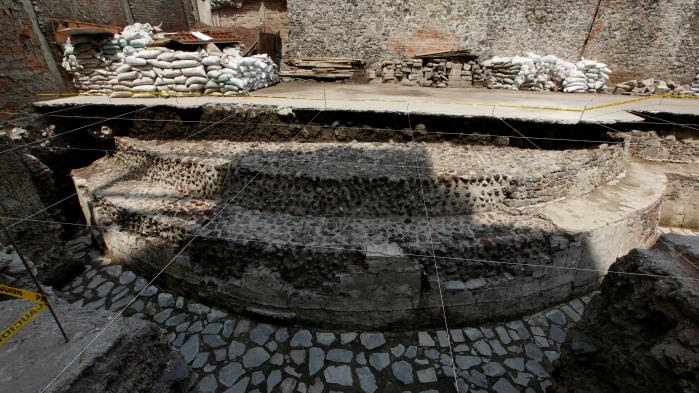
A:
[0,0,55,109]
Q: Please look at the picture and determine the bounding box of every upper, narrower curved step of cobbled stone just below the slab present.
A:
[113,138,624,217]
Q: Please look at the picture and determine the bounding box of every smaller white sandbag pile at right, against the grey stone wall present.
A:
[483,53,611,93]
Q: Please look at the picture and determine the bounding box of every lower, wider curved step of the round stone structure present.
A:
[73,147,665,328]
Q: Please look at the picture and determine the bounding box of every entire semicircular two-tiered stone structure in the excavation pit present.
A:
[73,107,666,329]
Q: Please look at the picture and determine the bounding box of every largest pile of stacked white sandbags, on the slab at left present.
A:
[63,24,279,98]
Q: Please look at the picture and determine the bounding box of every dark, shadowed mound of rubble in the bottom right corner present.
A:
[547,234,699,393]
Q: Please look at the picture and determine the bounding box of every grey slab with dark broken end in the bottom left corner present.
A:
[0,298,186,393]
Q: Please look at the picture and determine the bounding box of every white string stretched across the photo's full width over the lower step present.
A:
[0,216,699,281]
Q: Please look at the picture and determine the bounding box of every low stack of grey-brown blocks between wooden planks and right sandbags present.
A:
[369,59,483,87]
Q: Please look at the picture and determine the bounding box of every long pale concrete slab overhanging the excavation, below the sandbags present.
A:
[35,83,699,124]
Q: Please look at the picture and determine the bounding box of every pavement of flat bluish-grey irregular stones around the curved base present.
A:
[63,239,590,393]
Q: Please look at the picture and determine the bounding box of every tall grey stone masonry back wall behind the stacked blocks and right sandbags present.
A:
[288,0,699,83]
